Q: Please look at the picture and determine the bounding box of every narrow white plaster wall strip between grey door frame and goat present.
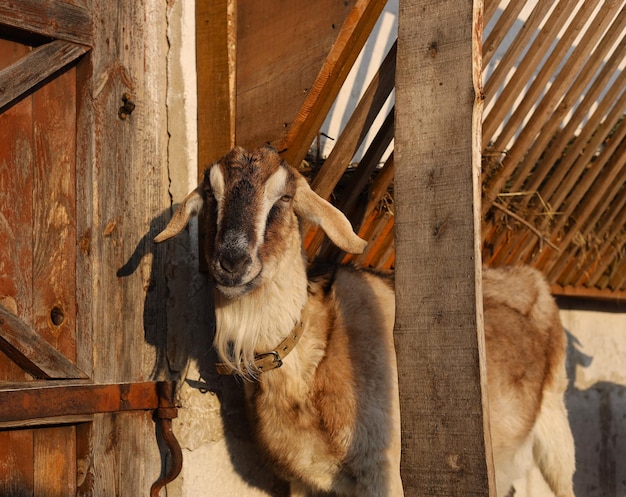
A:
[162,0,285,497]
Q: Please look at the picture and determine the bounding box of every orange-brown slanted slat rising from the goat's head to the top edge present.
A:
[278,0,386,166]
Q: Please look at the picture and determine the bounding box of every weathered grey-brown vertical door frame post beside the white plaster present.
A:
[84,0,171,497]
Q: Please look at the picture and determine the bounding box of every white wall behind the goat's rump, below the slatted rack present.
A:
[515,300,626,497]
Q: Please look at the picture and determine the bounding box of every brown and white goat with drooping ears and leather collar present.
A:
[155,148,574,497]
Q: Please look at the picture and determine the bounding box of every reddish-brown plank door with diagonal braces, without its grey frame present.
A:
[0,12,87,496]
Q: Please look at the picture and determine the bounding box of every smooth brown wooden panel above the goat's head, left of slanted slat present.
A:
[236,0,356,149]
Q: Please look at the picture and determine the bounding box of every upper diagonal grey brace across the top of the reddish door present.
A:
[0,40,89,109]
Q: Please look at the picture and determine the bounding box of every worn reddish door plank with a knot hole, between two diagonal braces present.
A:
[32,69,76,362]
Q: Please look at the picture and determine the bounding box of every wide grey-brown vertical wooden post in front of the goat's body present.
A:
[395,0,495,497]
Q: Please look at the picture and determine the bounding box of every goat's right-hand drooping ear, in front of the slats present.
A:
[293,175,367,254]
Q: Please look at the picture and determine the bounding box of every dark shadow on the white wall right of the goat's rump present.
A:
[565,331,626,497]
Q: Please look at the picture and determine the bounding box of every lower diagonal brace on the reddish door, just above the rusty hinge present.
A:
[0,306,86,378]
